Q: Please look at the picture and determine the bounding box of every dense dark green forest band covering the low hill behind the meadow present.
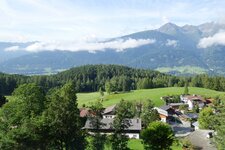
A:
[0,65,225,95]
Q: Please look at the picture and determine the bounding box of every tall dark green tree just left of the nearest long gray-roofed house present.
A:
[45,82,85,150]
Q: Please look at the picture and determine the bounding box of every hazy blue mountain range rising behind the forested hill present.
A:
[0,22,225,75]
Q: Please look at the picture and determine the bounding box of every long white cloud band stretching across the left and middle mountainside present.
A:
[25,39,155,52]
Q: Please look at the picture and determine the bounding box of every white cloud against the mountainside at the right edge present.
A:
[198,31,225,48]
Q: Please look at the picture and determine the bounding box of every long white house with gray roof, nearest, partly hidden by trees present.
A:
[83,118,142,139]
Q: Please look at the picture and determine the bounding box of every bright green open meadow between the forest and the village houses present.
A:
[77,87,225,107]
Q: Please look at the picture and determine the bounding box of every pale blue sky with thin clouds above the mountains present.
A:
[0,0,225,42]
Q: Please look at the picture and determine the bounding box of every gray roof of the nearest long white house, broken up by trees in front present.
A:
[84,118,141,130]
